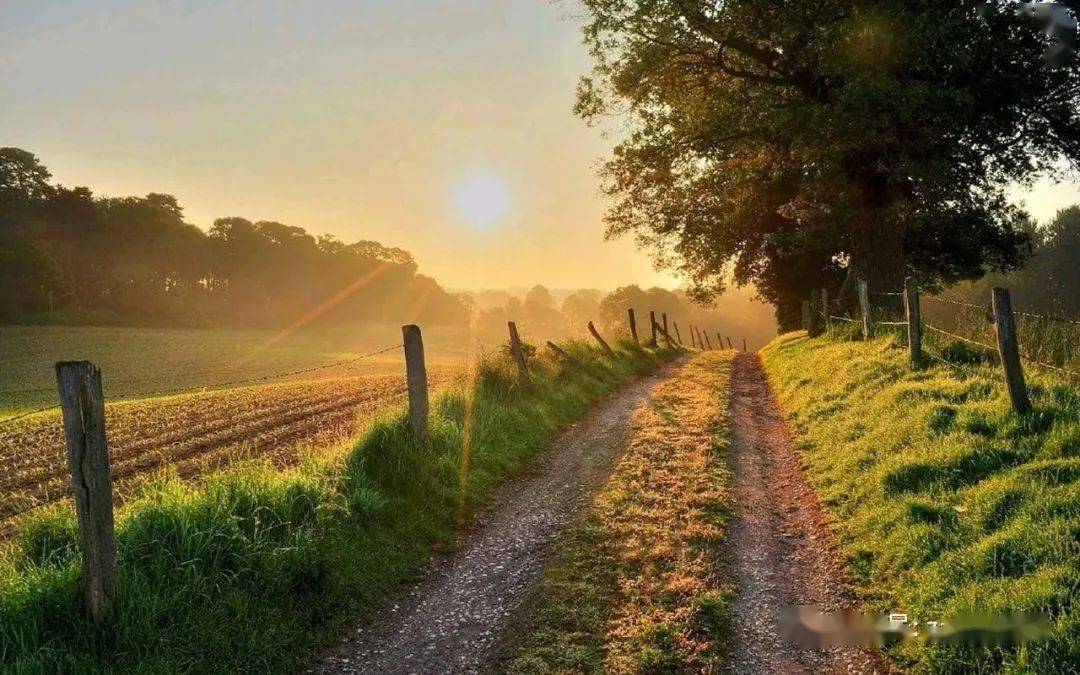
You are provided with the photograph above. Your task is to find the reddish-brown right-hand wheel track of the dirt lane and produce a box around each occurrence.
[729,354,890,673]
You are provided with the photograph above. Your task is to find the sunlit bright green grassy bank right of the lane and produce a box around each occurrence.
[764,334,1080,673]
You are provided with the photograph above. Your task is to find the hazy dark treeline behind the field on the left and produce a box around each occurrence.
[0,148,470,326]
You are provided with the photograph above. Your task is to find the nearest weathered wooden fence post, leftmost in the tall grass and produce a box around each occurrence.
[56,361,117,625]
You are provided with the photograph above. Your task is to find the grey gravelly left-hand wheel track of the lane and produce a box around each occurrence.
[314,365,675,673]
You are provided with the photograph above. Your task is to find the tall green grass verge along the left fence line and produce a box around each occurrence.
[0,345,673,673]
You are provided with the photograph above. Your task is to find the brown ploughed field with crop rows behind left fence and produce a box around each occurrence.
[0,367,455,521]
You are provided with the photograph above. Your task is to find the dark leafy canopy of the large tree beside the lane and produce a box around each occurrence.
[577,0,1080,320]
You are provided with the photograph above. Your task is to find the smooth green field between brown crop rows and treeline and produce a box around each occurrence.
[0,324,479,418]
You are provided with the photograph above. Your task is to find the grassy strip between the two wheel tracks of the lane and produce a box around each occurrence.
[510,352,733,673]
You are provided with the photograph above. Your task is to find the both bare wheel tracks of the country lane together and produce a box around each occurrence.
[312,354,888,673]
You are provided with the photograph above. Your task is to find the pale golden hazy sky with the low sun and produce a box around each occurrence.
[0,0,1080,288]
